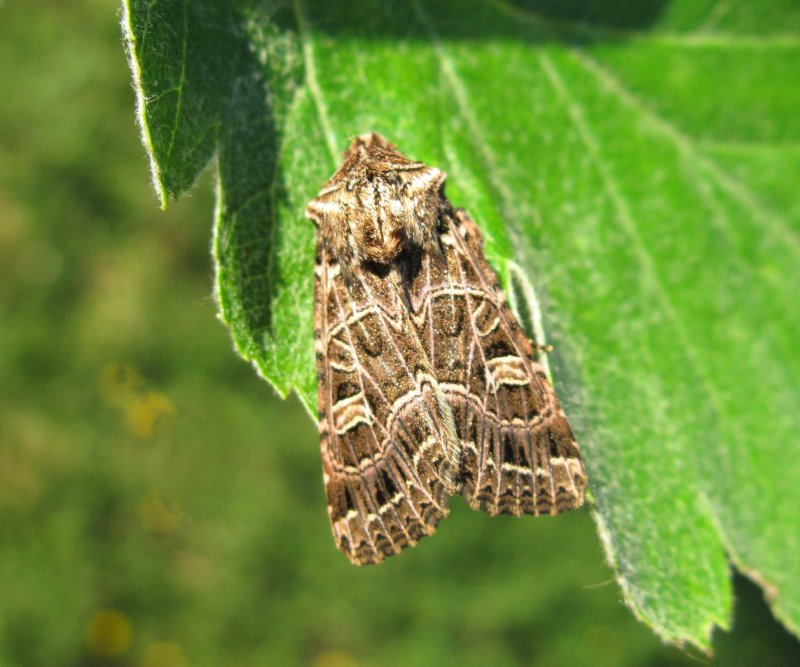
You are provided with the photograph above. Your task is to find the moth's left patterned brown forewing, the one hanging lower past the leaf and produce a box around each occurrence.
[315,243,457,564]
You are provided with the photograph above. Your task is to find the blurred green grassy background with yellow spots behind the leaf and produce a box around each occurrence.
[0,0,800,667]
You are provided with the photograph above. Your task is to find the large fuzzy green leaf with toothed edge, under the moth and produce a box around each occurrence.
[124,0,800,648]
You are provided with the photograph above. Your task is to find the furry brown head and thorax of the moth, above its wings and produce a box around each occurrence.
[306,133,446,267]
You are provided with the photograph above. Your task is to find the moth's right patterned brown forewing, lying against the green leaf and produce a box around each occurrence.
[409,206,586,516]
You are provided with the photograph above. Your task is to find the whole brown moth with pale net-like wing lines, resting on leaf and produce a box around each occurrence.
[306,133,586,565]
